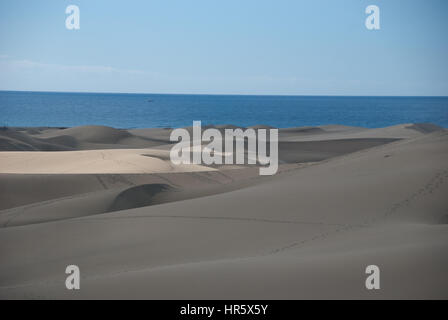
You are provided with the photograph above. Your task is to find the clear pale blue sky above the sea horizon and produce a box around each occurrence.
[0,0,448,96]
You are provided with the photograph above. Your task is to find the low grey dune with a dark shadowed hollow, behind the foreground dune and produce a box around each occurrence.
[0,170,270,228]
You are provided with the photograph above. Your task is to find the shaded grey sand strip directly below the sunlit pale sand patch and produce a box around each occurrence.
[0,166,266,212]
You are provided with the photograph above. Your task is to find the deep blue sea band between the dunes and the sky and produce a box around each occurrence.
[0,91,448,128]
